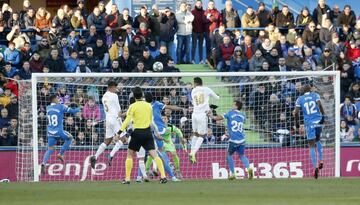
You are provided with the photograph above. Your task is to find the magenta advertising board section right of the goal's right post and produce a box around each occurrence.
[341,147,360,177]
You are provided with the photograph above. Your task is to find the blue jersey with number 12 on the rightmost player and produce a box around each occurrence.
[296,92,322,126]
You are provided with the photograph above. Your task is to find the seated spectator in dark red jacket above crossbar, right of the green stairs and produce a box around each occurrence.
[216,36,235,72]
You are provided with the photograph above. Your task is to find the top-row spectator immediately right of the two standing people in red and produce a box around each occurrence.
[221,0,241,28]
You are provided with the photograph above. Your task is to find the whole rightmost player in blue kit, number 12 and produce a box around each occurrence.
[294,85,325,179]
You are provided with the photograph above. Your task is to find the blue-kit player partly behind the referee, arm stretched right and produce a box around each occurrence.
[145,92,183,181]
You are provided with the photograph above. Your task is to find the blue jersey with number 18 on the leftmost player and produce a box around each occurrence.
[46,104,80,135]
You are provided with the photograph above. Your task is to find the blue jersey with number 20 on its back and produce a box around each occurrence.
[223,110,246,144]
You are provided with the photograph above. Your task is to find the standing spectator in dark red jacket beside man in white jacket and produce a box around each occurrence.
[191,0,207,64]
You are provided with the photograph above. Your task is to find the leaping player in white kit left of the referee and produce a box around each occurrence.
[90,81,123,169]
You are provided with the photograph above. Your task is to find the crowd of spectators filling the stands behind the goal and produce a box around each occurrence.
[0,0,360,146]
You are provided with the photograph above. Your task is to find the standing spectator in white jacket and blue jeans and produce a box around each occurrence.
[176,2,194,64]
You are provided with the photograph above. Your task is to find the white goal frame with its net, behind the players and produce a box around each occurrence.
[16,71,340,182]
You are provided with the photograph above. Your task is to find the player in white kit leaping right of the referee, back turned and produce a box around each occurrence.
[189,77,220,164]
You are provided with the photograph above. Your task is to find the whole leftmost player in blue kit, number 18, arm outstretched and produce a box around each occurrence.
[41,95,80,174]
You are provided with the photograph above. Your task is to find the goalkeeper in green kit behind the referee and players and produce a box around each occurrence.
[146,115,187,179]
